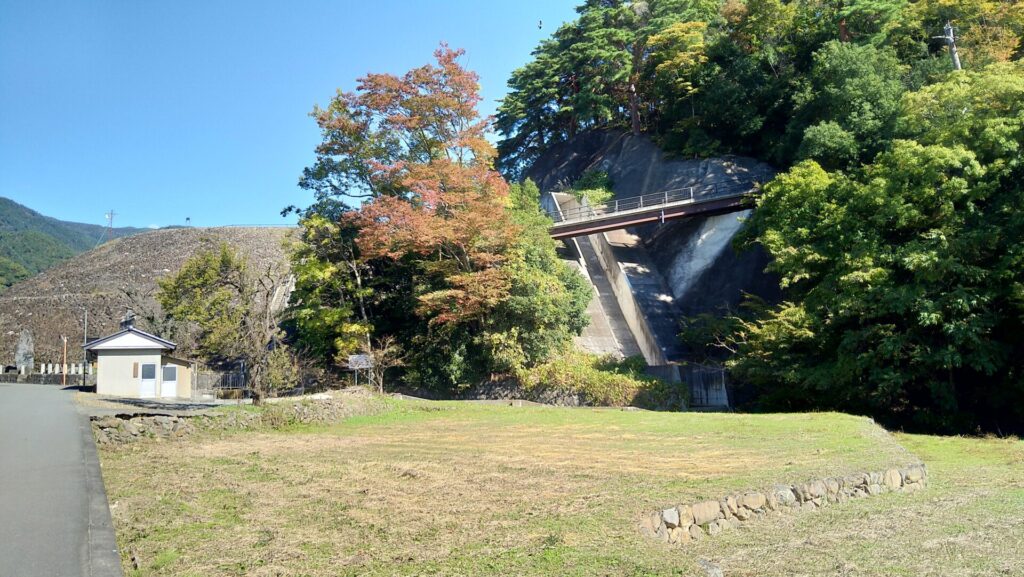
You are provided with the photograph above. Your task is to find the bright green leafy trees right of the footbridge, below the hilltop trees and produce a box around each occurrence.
[732,63,1024,430]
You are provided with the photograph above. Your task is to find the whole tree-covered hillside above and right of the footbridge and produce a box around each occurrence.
[497,0,1024,431]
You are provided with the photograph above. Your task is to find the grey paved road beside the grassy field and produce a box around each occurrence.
[0,383,121,577]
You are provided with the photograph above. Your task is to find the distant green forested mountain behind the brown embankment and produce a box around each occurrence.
[0,197,143,291]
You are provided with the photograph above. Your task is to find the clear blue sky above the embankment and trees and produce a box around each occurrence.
[0,0,577,226]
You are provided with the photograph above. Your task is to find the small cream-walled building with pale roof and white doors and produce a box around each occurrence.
[85,327,193,399]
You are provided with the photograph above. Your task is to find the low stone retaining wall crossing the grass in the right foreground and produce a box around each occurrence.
[640,464,928,543]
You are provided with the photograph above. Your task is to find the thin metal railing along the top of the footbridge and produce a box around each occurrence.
[548,173,769,224]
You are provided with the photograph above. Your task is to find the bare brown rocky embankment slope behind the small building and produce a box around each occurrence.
[0,228,292,364]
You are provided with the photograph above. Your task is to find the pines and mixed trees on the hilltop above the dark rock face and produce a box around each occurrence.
[497,0,1024,176]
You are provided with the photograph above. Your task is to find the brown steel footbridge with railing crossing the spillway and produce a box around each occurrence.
[547,173,770,240]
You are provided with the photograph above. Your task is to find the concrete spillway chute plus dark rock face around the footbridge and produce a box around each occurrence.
[525,131,780,401]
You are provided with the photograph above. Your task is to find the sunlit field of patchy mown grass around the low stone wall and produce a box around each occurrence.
[100,402,1024,576]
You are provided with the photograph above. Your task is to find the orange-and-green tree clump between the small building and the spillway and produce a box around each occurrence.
[293,45,589,388]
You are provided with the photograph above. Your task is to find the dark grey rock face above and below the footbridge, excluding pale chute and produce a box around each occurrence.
[526,131,780,361]
